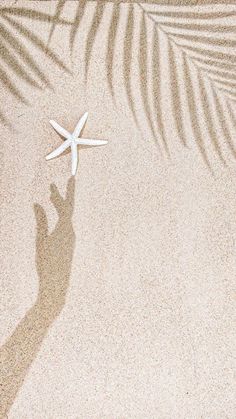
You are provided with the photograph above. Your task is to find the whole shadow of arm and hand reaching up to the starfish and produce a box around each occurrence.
[0,177,75,418]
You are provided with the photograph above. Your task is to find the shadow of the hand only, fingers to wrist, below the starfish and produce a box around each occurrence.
[34,177,75,321]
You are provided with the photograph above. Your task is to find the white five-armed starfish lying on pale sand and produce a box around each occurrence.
[46,112,108,176]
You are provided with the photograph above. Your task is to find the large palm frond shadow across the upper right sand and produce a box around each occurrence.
[70,0,236,171]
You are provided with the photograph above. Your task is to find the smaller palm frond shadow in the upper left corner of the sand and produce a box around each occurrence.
[0,7,71,125]
